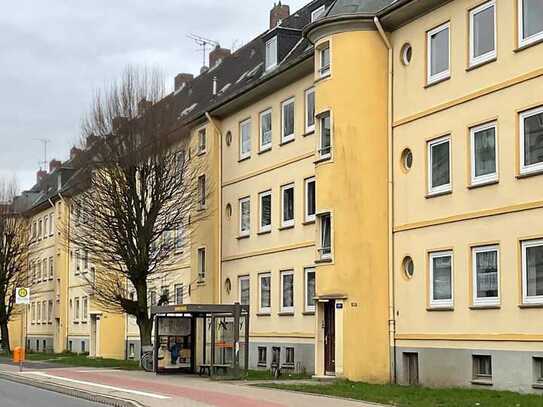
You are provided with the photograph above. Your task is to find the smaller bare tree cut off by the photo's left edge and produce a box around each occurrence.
[0,179,31,351]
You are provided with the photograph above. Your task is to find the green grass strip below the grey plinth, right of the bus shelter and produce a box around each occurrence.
[257,381,543,407]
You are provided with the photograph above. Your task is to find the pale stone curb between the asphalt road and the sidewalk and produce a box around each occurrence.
[0,371,145,407]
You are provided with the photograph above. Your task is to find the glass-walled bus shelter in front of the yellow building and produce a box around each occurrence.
[151,303,249,379]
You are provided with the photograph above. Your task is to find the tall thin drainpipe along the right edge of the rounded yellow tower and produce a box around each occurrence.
[373,17,396,383]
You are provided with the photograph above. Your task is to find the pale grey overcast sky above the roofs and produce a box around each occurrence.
[0,0,309,189]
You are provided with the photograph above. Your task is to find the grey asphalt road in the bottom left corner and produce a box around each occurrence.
[0,379,103,407]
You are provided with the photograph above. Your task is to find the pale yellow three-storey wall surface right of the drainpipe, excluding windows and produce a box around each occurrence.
[392,0,543,349]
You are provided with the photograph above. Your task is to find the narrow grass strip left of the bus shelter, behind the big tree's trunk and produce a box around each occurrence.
[26,353,140,370]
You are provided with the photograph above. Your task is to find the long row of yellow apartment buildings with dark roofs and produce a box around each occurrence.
[8,0,543,391]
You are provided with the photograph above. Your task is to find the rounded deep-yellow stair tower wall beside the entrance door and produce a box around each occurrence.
[316,31,389,382]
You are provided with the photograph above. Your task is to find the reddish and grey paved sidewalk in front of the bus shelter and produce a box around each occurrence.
[0,364,382,407]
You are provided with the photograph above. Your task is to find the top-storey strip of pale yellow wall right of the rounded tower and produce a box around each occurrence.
[391,0,543,121]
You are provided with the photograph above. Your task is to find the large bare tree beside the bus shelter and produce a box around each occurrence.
[64,68,209,346]
